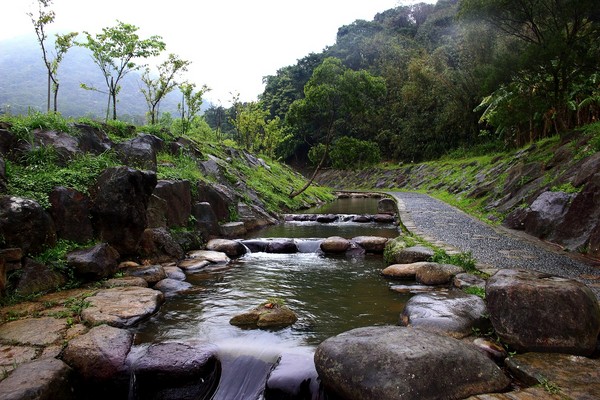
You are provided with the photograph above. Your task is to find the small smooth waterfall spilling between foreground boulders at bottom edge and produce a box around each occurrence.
[211,341,280,400]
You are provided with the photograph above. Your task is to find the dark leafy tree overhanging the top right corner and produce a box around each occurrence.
[461,0,600,132]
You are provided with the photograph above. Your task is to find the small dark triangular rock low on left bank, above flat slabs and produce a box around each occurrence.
[15,258,67,296]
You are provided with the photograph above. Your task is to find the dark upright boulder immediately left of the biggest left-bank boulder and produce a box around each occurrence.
[48,186,94,243]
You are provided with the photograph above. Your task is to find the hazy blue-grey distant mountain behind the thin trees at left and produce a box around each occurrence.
[0,36,191,124]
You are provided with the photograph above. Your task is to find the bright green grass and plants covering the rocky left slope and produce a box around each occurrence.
[0,113,334,212]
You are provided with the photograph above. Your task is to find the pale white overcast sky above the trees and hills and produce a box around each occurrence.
[0,0,433,104]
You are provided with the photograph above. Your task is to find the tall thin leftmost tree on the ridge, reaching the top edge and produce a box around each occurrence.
[27,0,78,112]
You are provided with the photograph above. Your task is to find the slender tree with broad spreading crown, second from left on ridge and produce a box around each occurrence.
[80,21,165,119]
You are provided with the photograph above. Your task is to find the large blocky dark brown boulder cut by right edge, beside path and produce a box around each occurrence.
[486,269,600,355]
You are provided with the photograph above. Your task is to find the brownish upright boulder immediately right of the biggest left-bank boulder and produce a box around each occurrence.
[153,180,192,228]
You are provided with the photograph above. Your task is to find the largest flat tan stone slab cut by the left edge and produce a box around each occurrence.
[0,317,67,346]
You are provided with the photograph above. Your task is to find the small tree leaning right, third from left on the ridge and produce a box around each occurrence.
[141,53,191,125]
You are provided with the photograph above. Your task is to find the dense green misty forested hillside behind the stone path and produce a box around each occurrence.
[207,0,600,168]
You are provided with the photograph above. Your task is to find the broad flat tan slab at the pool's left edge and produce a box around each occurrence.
[81,286,164,328]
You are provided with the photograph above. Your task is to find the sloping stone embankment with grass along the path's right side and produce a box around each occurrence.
[316,136,600,258]
